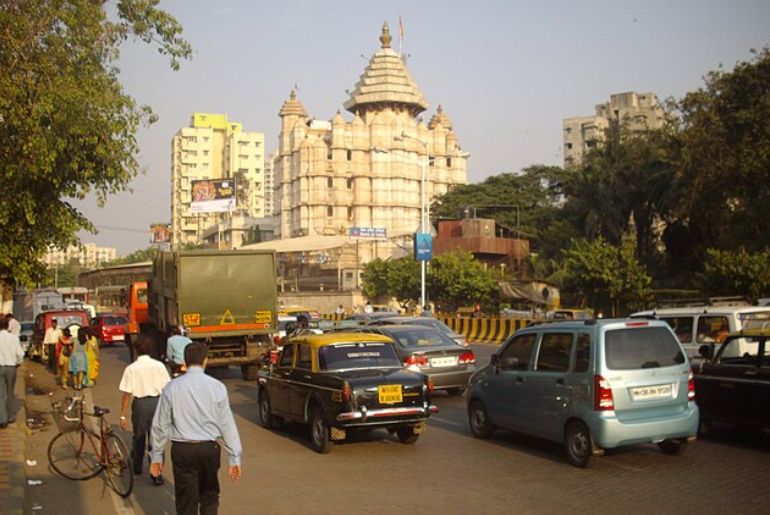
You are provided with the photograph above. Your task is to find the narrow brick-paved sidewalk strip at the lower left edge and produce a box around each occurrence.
[0,362,27,514]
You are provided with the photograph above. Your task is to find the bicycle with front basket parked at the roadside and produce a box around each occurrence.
[48,396,134,497]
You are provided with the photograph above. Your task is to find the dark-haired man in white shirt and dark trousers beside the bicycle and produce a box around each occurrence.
[118,334,170,486]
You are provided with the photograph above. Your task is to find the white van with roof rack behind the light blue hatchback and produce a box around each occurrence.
[631,306,770,358]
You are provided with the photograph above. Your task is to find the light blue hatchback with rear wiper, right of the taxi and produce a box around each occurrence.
[467,319,698,467]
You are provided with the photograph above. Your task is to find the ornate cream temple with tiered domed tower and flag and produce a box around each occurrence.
[274,24,469,262]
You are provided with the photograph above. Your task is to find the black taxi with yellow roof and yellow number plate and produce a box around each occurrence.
[257,332,438,453]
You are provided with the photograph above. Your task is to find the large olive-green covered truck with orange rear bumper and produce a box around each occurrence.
[127,250,277,380]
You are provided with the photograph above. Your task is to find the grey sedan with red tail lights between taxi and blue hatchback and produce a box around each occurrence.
[362,325,476,395]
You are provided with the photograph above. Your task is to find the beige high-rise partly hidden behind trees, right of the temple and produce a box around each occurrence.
[564,92,665,168]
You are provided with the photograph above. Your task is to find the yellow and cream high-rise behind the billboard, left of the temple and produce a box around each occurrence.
[171,113,266,248]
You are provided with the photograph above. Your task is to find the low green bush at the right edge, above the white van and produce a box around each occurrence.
[700,247,770,300]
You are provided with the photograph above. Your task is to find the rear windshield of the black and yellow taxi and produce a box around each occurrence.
[318,342,402,371]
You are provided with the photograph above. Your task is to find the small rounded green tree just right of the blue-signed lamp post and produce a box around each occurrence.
[428,251,498,311]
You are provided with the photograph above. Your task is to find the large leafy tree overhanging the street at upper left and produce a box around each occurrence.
[0,0,192,284]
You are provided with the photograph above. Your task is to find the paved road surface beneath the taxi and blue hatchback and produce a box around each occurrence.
[21,345,770,515]
